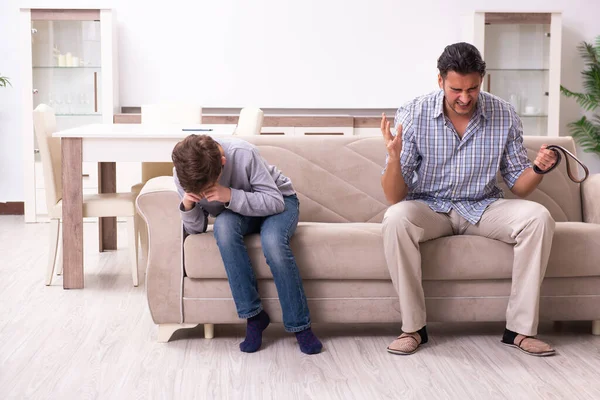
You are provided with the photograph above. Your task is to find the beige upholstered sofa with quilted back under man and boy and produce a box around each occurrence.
[137,136,600,341]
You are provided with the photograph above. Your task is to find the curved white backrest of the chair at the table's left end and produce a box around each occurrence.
[33,104,62,213]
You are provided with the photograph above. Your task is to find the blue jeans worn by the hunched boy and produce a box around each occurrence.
[214,195,310,332]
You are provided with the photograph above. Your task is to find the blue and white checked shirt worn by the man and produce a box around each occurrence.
[384,90,531,224]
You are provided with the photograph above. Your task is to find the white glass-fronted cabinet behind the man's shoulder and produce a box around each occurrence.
[471,11,562,136]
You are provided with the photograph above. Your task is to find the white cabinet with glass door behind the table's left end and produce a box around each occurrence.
[31,10,105,216]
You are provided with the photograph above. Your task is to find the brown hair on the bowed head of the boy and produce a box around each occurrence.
[171,135,223,194]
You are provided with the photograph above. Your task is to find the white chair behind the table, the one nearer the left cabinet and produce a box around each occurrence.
[142,103,202,182]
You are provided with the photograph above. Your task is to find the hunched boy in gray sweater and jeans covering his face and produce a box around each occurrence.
[172,135,323,354]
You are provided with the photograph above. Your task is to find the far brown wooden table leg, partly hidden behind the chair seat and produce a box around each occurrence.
[98,162,117,252]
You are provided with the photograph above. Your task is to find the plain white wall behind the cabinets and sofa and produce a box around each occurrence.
[0,0,600,201]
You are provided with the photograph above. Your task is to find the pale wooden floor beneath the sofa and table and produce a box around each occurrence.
[0,216,600,400]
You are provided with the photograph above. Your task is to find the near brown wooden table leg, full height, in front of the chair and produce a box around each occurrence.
[61,138,83,289]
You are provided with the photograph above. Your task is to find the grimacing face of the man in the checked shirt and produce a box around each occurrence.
[438,71,483,116]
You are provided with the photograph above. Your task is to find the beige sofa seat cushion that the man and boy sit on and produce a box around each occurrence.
[184,222,600,280]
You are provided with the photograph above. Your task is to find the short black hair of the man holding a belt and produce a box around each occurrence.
[438,42,485,79]
